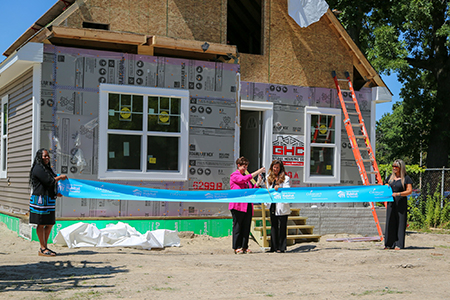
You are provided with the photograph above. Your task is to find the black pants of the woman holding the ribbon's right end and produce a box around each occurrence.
[384,197,408,249]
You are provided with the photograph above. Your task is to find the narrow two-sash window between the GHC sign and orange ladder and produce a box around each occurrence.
[303,107,341,184]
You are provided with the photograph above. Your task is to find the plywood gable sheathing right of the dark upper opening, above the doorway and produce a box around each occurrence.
[241,0,353,88]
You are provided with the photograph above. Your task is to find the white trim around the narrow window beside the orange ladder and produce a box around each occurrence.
[303,106,341,184]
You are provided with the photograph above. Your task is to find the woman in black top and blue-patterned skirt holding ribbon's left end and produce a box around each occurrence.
[30,148,67,256]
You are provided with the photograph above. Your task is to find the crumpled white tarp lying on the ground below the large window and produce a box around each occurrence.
[53,222,180,250]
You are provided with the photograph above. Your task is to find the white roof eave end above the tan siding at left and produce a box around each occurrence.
[0,43,44,88]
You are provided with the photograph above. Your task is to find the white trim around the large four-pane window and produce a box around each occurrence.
[98,83,189,181]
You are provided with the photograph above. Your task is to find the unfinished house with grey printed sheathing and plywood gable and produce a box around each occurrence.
[0,0,391,234]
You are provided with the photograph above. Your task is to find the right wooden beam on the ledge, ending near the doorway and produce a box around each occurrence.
[148,36,237,56]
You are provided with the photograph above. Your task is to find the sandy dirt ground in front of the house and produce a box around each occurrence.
[0,223,450,300]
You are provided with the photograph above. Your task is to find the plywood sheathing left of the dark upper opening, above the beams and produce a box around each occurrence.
[60,0,226,43]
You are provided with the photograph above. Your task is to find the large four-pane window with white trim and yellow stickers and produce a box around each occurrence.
[99,84,189,180]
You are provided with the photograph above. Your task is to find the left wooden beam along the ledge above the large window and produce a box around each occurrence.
[50,26,147,45]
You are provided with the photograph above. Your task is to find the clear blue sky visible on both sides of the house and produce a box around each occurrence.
[0,0,401,120]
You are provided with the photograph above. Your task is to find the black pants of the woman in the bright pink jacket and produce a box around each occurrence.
[231,203,252,250]
